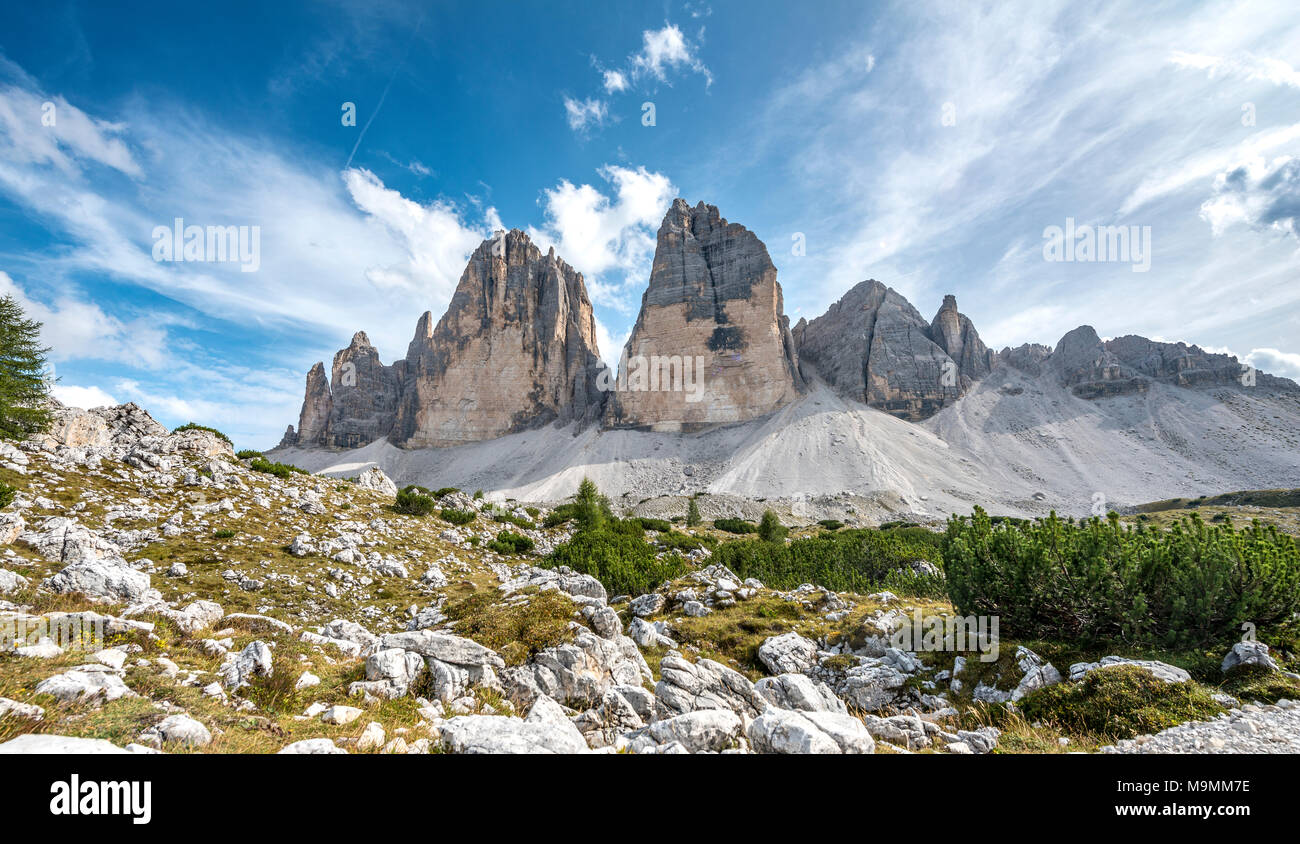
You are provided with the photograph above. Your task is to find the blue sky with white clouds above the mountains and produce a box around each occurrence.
[0,0,1300,446]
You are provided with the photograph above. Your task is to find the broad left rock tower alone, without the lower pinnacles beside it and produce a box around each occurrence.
[394,223,603,447]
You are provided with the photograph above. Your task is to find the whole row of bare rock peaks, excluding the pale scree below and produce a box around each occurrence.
[281,198,1295,449]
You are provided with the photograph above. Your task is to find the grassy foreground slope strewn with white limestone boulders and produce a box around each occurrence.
[0,404,1294,754]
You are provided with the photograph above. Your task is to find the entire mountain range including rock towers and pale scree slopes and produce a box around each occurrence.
[274,199,1300,519]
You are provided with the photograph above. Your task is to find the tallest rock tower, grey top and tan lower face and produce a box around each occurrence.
[605,199,802,430]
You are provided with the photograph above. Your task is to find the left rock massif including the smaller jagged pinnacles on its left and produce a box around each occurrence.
[282,223,605,449]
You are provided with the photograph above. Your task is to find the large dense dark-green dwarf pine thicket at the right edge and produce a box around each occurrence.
[944,507,1300,648]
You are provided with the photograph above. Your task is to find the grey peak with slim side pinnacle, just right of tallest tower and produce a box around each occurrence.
[796,281,992,421]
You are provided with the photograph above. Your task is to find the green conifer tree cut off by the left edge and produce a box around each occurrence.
[0,295,51,440]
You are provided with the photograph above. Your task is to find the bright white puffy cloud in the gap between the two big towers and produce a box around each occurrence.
[528,165,676,312]
